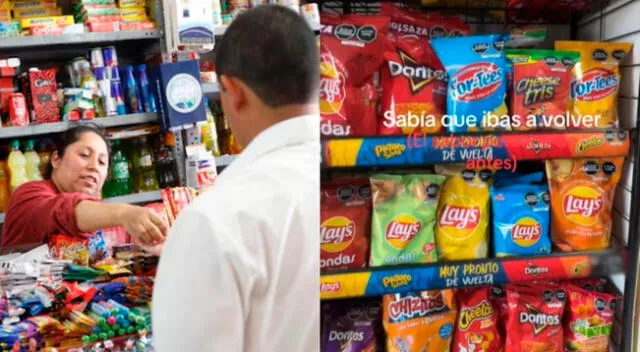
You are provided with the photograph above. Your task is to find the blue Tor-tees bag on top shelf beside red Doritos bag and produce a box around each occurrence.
[431,35,511,133]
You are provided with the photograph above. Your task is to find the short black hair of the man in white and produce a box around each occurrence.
[215,5,320,108]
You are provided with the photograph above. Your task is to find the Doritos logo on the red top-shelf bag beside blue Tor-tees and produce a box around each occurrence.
[389,50,447,94]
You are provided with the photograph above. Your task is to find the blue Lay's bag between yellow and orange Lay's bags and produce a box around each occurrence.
[490,173,551,257]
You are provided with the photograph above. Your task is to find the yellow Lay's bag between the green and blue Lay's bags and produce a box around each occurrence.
[436,165,491,260]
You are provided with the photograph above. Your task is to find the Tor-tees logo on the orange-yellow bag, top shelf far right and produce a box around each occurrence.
[571,67,619,101]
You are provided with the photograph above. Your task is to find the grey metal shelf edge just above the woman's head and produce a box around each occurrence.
[0,113,158,139]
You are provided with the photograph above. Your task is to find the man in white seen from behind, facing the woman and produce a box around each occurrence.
[153,5,320,352]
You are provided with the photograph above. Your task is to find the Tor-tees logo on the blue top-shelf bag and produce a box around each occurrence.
[451,62,503,102]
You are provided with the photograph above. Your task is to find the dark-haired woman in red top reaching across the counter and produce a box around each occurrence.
[2,124,168,249]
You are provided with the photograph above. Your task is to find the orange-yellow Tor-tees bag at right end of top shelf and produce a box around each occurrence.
[555,41,631,128]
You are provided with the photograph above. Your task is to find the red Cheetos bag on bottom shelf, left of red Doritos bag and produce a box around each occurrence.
[451,286,503,352]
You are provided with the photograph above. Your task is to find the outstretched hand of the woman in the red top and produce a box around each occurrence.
[121,205,169,245]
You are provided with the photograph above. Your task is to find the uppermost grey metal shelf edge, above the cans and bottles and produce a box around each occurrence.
[0,29,162,50]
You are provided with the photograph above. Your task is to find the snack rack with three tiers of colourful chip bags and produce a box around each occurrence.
[319,0,640,352]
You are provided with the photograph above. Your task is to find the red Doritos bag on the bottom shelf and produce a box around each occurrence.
[505,283,567,352]
